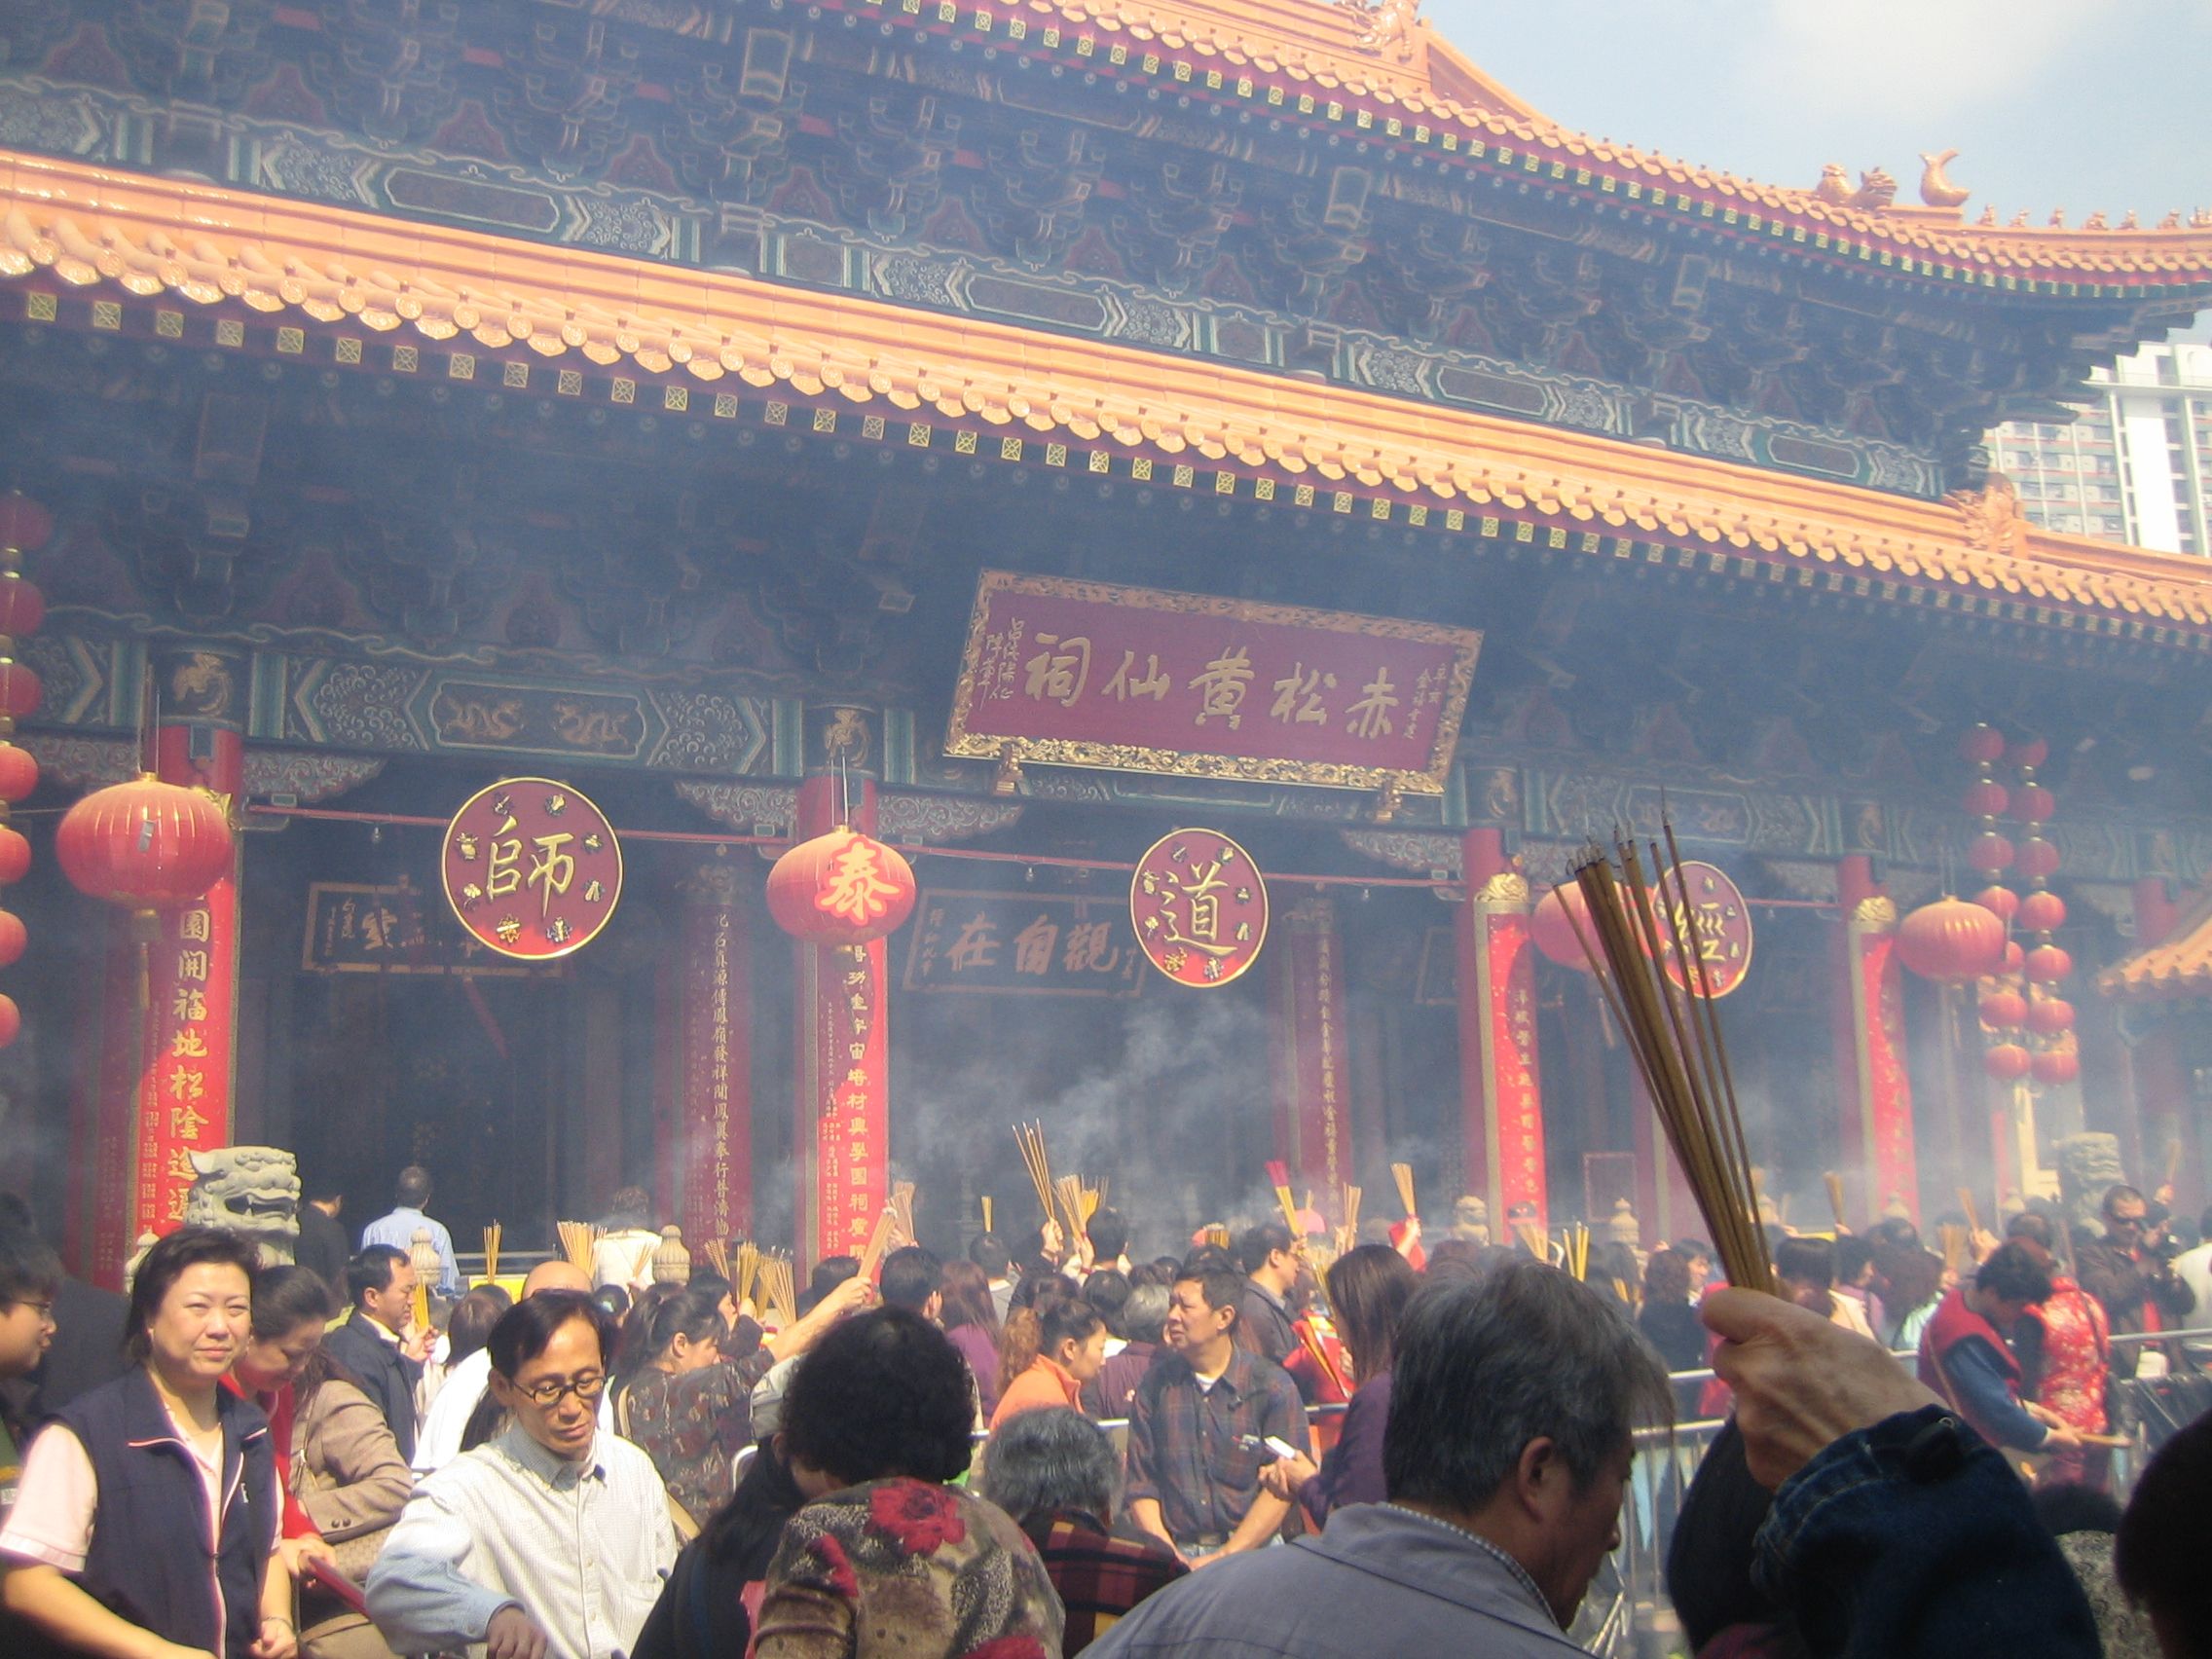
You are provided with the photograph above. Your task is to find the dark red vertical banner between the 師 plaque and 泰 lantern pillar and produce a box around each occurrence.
[677,865,752,1243]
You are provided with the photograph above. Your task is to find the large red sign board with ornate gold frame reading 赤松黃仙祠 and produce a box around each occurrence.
[944,571,1482,794]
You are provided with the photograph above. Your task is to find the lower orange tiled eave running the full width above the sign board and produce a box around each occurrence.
[13,153,2212,648]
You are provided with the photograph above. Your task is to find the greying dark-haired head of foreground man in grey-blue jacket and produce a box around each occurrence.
[1382,1261,1673,1628]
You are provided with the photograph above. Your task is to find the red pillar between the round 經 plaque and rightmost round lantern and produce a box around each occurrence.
[1833,854,1920,1226]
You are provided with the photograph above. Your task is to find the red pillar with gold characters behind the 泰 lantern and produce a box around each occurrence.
[792,774,892,1263]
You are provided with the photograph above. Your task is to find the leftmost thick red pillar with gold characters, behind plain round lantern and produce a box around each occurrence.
[78,650,245,1287]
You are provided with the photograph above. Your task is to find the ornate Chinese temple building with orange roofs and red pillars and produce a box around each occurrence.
[0,0,2212,1278]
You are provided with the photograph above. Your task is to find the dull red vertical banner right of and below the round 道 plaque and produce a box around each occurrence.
[1272,898,1356,1210]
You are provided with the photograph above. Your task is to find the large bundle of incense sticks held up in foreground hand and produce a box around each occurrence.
[1568,827,1774,1292]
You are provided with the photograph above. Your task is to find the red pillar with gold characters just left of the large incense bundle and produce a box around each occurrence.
[1457,830,1548,1243]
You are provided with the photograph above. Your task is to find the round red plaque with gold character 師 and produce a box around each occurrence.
[440,779,621,962]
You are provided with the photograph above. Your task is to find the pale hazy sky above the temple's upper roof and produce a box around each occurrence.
[1422,0,2212,223]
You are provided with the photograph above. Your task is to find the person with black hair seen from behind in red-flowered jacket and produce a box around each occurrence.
[752,1308,1064,1659]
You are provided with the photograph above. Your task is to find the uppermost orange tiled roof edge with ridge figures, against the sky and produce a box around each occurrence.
[893,0,2212,285]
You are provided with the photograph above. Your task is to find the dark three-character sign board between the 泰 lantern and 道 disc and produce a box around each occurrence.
[903,887,1141,998]
